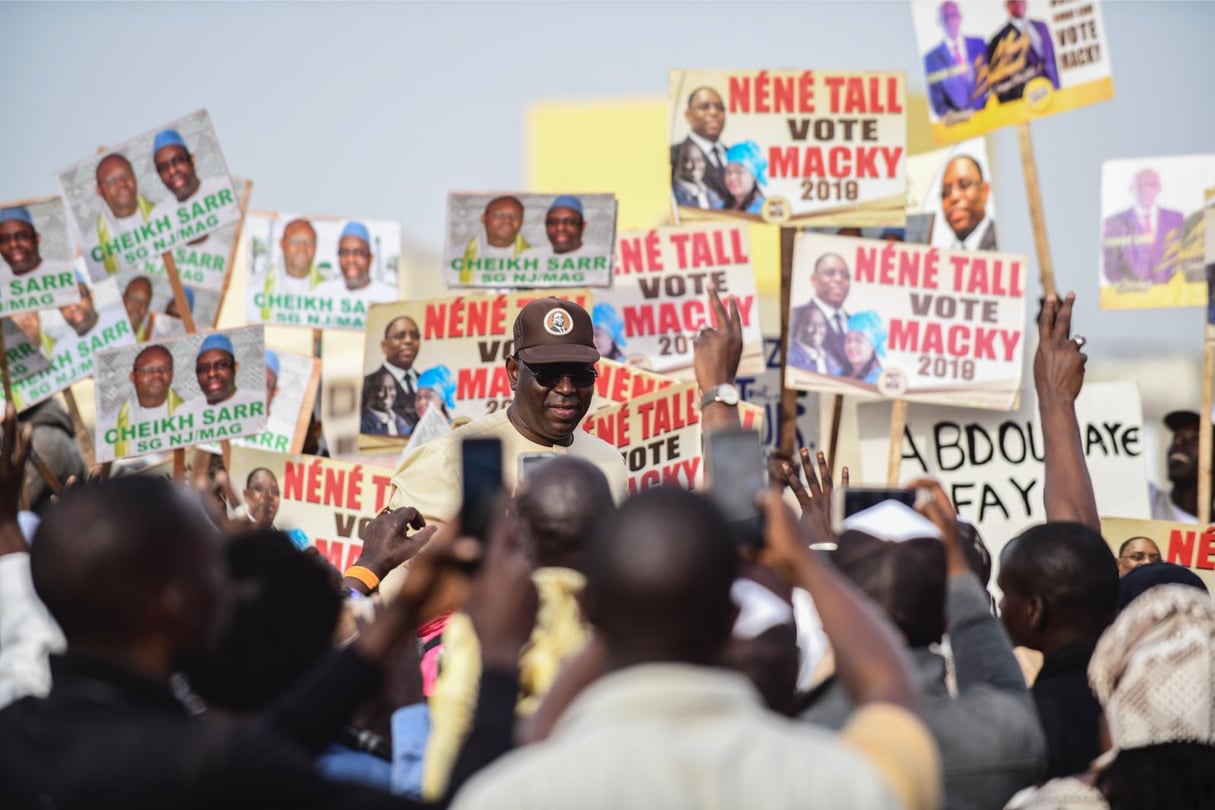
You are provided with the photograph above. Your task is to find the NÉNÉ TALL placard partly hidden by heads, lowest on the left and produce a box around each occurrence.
[228,446,392,571]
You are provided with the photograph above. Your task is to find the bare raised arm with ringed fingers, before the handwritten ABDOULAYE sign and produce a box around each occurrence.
[1034,293,1101,532]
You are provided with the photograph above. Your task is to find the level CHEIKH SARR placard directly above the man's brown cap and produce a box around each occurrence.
[443,192,616,289]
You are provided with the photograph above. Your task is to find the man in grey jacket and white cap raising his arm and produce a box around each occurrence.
[802,481,1046,809]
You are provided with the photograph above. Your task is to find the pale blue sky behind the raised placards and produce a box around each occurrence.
[0,0,1215,356]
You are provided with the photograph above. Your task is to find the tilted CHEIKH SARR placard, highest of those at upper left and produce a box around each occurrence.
[58,109,241,279]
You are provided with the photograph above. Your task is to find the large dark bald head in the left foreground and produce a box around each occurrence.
[29,476,225,664]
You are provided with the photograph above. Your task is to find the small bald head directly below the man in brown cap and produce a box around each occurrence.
[515,455,616,570]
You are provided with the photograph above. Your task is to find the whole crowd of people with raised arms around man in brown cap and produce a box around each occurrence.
[0,291,1215,809]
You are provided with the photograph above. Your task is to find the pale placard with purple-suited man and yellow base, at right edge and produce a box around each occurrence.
[1100,154,1215,310]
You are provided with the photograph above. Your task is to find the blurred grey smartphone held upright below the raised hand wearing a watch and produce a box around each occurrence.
[705,430,765,548]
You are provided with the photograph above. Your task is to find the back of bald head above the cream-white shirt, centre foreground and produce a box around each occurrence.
[583,487,740,668]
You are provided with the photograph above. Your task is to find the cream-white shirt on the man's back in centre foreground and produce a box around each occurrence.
[453,664,932,810]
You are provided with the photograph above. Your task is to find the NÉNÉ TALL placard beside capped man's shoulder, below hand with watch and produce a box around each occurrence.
[582,383,763,494]
